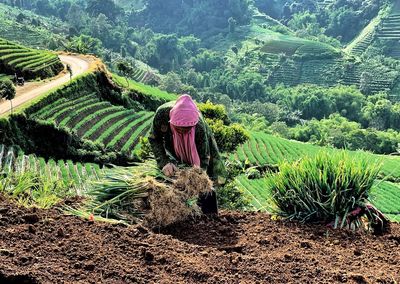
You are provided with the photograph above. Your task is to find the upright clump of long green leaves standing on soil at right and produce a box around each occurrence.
[268,151,389,233]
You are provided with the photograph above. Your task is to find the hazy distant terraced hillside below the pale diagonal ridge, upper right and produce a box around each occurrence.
[228,22,399,93]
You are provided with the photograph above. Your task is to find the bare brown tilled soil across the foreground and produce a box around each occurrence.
[0,196,400,284]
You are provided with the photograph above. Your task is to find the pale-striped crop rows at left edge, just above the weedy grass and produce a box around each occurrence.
[0,144,103,195]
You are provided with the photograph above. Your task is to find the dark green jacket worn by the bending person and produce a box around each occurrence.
[149,101,226,181]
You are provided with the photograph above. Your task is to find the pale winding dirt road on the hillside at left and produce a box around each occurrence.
[0,55,90,115]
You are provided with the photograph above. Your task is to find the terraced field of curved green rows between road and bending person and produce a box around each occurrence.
[32,93,153,155]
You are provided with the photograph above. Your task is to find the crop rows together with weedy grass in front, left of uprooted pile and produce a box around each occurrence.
[0,144,102,200]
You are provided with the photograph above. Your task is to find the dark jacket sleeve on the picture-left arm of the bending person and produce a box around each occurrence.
[149,109,170,169]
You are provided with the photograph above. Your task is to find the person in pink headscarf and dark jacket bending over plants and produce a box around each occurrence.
[149,95,225,214]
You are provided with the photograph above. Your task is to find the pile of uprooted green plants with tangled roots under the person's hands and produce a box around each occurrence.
[73,162,213,228]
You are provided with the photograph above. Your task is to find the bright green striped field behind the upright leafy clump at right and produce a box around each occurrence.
[229,133,400,220]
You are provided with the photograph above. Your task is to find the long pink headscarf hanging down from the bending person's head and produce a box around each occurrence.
[169,95,200,167]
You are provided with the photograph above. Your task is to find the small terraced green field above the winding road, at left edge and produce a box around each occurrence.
[0,38,64,79]
